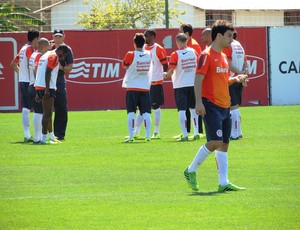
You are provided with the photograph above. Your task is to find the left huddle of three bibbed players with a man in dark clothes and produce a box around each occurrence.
[11,29,73,144]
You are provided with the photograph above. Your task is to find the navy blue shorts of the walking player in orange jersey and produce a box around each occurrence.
[202,98,231,144]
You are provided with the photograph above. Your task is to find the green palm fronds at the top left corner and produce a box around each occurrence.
[0,1,45,32]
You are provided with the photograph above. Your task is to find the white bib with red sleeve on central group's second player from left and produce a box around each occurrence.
[145,43,168,83]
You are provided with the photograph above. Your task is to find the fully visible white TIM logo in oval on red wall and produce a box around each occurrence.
[67,57,125,84]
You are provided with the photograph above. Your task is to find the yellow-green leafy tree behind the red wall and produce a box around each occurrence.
[77,0,185,29]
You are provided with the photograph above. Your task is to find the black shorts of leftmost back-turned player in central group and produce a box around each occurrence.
[126,90,151,115]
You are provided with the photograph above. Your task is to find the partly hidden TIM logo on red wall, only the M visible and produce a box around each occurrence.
[246,55,266,79]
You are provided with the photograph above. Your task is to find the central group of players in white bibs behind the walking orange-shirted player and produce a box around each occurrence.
[123,24,247,142]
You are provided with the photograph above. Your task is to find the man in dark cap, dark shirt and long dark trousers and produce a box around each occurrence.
[53,29,74,140]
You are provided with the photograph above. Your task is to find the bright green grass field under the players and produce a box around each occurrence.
[0,106,300,229]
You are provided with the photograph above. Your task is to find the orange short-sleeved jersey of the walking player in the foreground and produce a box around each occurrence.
[197,47,230,108]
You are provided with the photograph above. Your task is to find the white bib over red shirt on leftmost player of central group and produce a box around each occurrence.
[122,51,151,91]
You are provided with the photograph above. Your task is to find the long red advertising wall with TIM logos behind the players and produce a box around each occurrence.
[0,28,268,110]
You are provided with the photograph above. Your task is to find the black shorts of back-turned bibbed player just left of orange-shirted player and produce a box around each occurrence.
[174,86,196,111]
